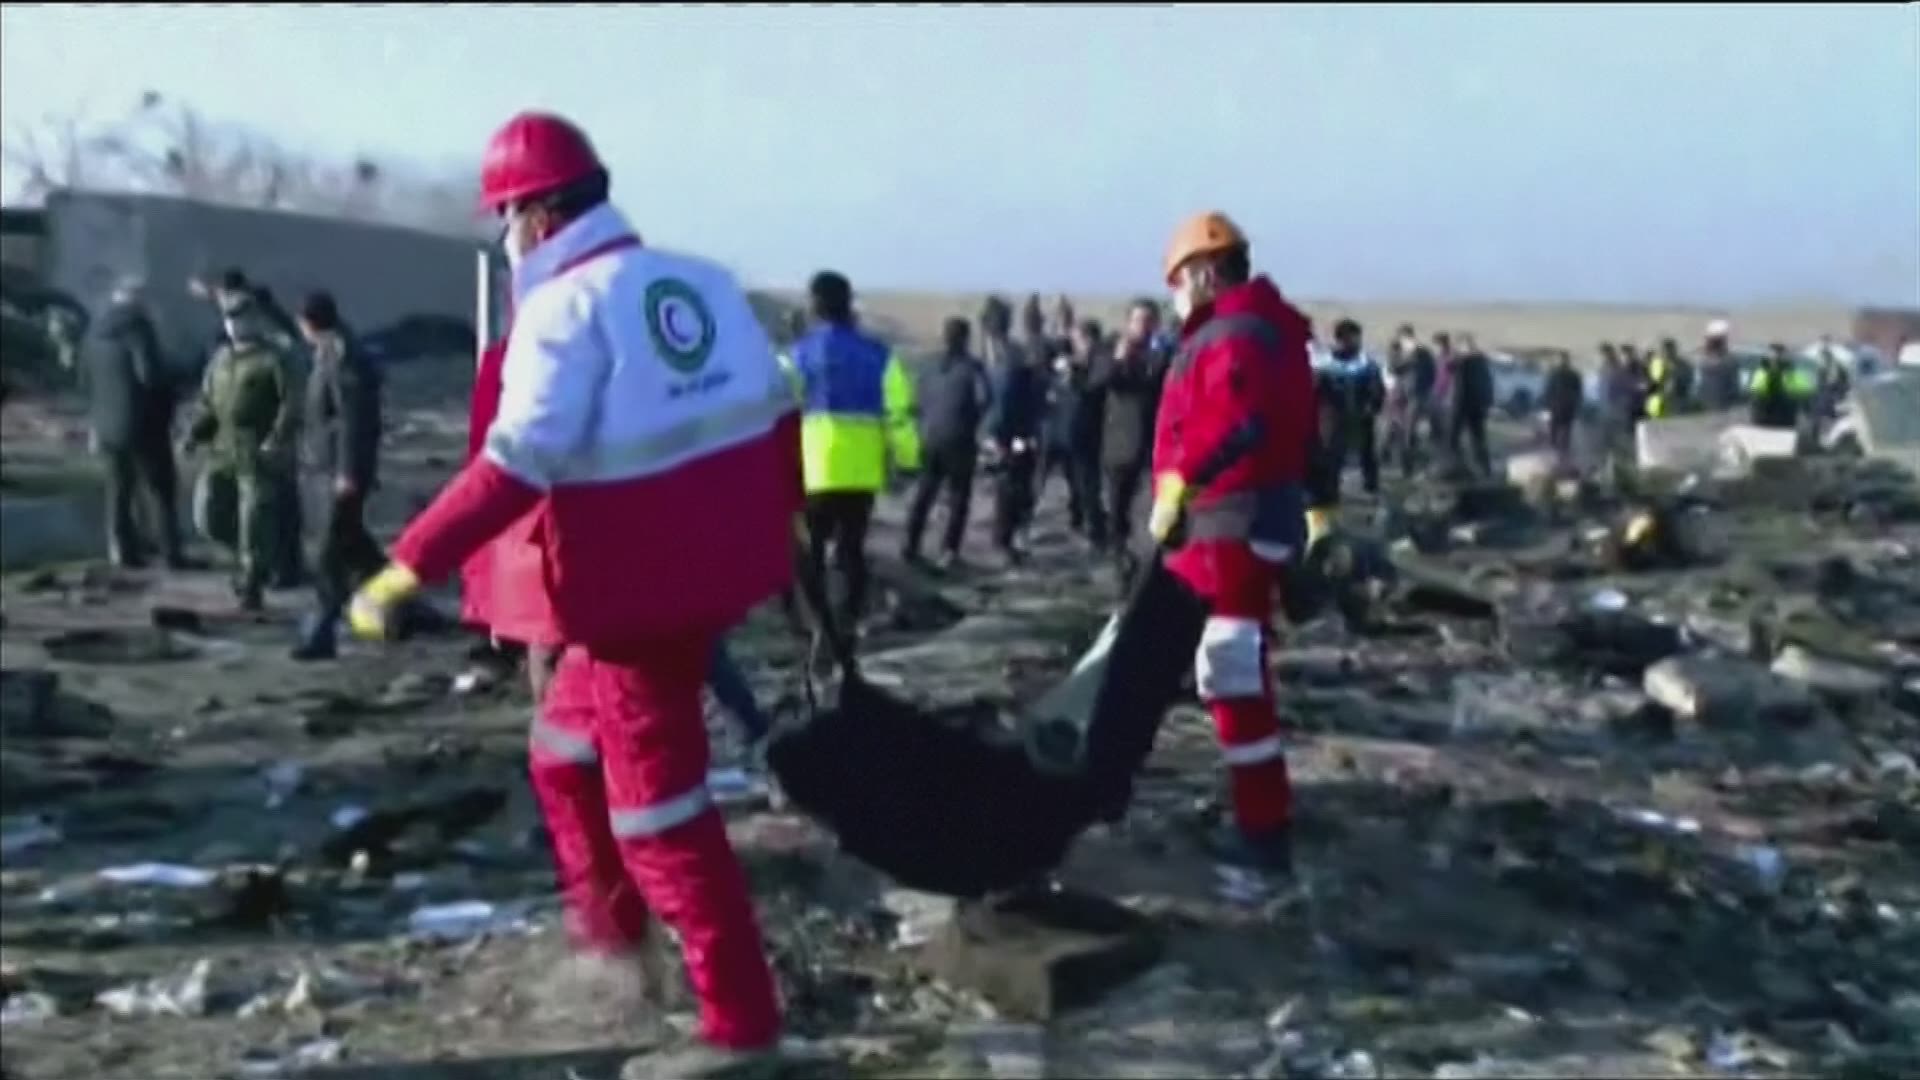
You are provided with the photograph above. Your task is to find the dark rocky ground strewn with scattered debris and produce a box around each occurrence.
[0,372,1920,1080]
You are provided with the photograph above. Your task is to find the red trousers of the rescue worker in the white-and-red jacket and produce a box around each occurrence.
[530,634,780,1049]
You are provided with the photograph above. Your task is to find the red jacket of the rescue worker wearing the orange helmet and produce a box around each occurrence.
[1154,277,1317,594]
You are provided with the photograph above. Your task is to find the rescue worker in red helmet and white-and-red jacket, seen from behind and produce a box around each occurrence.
[349,113,801,1076]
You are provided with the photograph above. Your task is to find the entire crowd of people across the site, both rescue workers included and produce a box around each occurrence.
[52,102,1881,1076]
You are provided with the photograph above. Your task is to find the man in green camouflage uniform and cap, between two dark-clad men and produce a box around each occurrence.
[186,294,300,611]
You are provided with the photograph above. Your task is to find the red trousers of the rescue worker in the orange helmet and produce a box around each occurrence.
[1167,540,1294,834]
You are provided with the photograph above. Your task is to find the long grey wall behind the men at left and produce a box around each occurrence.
[42,192,476,359]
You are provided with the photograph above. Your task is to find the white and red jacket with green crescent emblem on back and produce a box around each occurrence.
[394,206,803,648]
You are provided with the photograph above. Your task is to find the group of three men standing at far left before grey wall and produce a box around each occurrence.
[81,269,384,659]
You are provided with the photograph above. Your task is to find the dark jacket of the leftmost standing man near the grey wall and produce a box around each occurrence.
[83,304,173,454]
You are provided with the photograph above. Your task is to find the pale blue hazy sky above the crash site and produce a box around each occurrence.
[0,4,1920,304]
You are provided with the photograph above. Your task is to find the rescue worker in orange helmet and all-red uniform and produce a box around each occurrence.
[1150,213,1317,872]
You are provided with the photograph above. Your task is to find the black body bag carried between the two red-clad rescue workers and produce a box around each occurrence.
[766,429,1258,897]
